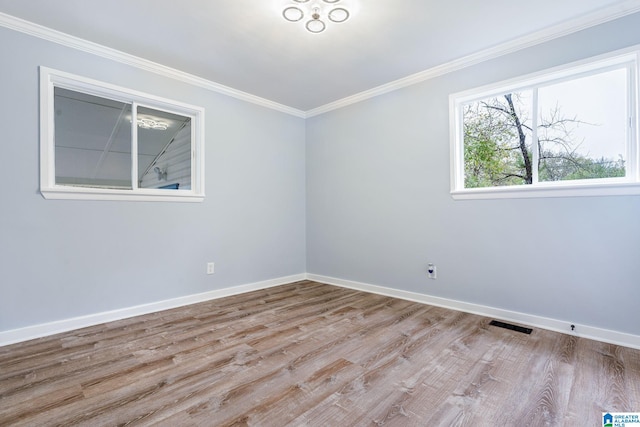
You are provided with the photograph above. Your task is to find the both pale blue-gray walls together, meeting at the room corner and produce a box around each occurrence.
[0,11,640,334]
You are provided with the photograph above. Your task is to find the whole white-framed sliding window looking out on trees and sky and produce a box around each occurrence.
[450,52,640,199]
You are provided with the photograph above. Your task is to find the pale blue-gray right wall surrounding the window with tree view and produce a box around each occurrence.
[307,14,640,340]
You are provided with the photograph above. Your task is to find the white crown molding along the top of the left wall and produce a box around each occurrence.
[0,12,306,118]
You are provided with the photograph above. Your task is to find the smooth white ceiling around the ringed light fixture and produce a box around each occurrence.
[0,0,640,112]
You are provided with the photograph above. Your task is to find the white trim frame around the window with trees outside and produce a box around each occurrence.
[449,45,640,200]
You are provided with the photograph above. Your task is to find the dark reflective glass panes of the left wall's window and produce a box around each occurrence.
[54,87,192,190]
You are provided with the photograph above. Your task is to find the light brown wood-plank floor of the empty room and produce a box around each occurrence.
[0,281,640,427]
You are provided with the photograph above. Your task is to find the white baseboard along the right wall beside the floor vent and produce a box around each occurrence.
[307,273,640,349]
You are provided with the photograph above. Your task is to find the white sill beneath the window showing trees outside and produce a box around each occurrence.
[451,182,640,200]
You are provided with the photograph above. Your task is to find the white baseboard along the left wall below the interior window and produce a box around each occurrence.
[0,274,306,346]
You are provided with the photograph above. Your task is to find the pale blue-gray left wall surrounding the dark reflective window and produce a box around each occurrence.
[0,27,306,331]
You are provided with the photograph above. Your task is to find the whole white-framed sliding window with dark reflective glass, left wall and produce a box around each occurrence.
[40,67,204,202]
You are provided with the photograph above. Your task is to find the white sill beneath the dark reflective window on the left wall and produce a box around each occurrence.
[40,187,204,203]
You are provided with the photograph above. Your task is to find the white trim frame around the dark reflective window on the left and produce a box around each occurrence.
[40,66,205,202]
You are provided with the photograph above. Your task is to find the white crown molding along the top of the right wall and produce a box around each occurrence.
[305,0,640,118]
